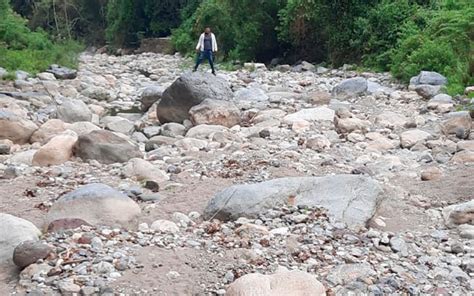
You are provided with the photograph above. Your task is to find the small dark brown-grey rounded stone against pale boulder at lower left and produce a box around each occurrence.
[13,240,51,268]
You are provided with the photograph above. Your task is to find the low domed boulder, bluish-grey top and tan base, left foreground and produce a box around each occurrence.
[45,183,141,228]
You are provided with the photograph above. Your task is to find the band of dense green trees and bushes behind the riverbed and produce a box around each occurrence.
[0,0,474,92]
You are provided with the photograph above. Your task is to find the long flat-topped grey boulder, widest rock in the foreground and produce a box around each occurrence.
[205,175,382,227]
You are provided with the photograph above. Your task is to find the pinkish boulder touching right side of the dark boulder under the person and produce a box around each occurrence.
[189,99,240,127]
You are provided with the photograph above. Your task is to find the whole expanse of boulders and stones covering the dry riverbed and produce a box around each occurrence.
[0,53,474,295]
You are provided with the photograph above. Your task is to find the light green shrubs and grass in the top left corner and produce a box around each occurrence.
[0,0,81,73]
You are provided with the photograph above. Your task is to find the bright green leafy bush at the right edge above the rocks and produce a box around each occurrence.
[391,2,474,94]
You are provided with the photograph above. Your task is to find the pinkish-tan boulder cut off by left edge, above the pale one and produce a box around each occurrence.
[0,109,38,144]
